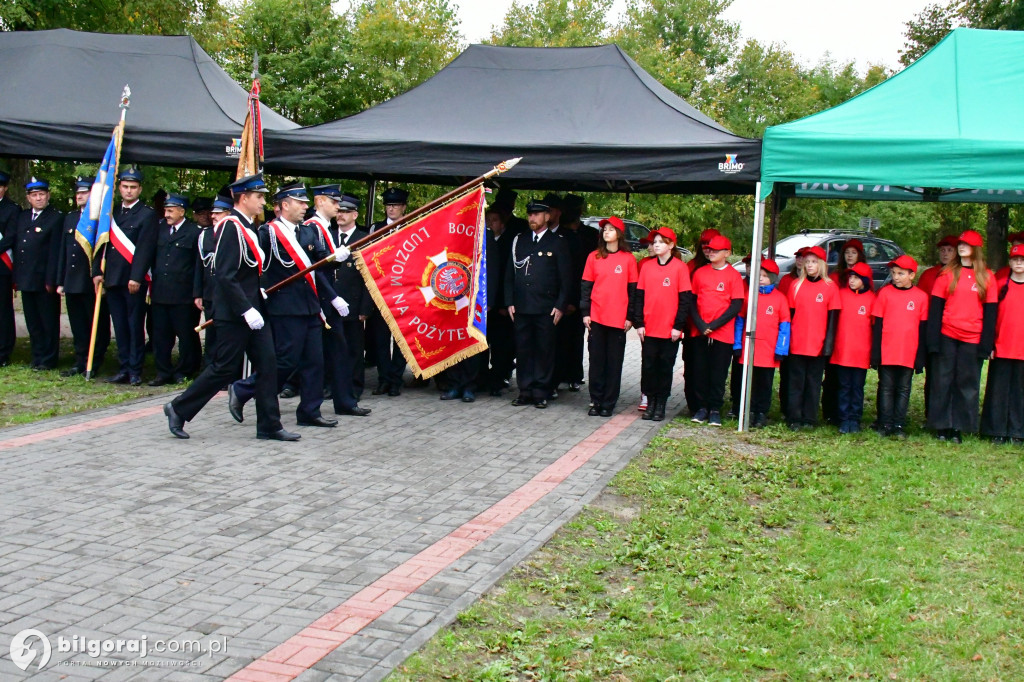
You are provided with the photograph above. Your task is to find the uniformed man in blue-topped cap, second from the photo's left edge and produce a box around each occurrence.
[13,178,63,370]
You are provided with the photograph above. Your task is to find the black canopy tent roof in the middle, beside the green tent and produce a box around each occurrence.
[266,45,761,194]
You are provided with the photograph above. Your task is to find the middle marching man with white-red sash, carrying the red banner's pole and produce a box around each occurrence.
[227,183,348,427]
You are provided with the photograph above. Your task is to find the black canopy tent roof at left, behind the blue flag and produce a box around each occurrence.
[0,29,298,169]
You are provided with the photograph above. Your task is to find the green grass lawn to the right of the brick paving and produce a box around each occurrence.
[389,378,1024,681]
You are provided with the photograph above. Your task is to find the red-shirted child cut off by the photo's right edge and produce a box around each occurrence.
[981,243,1024,445]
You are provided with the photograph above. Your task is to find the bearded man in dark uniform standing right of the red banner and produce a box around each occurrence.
[505,200,572,408]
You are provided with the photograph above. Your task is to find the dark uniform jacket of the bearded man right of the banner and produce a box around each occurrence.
[505,229,572,314]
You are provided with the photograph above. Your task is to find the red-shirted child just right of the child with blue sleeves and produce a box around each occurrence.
[786,247,842,431]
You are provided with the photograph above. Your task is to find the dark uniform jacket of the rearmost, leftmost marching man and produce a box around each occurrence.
[213,209,266,325]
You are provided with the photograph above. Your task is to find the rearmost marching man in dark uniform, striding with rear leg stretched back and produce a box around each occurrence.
[164,173,301,440]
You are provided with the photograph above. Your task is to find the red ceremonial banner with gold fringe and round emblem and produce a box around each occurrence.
[352,186,487,378]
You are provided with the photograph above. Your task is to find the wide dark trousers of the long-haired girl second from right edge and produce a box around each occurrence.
[928,334,982,433]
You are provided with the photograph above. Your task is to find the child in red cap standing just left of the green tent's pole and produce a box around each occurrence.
[686,235,745,426]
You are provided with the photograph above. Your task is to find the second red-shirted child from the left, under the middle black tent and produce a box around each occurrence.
[631,227,690,422]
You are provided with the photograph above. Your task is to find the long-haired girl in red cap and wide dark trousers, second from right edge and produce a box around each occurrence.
[928,229,999,443]
